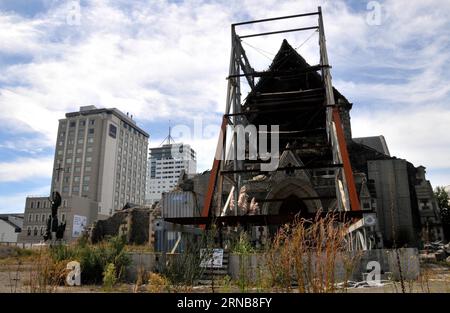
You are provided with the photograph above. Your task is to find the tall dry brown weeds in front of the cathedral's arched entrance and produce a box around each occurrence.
[265,212,356,293]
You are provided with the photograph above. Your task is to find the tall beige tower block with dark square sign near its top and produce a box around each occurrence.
[52,106,149,216]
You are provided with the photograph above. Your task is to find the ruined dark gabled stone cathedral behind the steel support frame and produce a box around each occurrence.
[160,35,444,250]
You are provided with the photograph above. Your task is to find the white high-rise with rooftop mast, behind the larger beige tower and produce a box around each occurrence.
[145,142,197,204]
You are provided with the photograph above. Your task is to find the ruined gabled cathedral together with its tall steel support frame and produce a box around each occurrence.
[112,8,445,252]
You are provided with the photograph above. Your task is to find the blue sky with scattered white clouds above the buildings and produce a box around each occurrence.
[0,0,450,213]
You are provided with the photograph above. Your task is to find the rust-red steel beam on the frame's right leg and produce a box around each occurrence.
[333,107,361,211]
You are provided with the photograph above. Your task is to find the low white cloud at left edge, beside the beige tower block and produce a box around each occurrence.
[0,157,53,183]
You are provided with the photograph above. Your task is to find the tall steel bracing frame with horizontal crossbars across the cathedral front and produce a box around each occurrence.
[197,7,361,229]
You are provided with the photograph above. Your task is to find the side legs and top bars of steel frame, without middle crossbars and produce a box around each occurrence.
[202,7,361,228]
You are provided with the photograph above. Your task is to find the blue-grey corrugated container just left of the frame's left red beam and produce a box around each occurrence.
[161,191,200,218]
